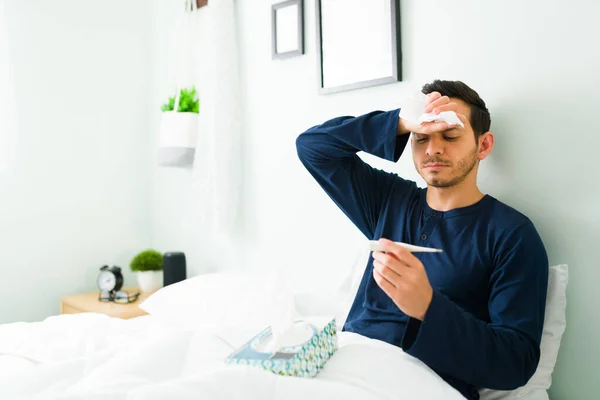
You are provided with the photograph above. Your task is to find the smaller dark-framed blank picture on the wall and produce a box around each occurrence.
[271,0,304,59]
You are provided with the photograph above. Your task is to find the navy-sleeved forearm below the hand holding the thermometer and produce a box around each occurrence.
[402,292,540,390]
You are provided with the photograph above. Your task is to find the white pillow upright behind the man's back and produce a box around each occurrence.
[480,264,569,400]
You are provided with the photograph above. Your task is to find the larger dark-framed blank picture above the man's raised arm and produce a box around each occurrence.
[316,0,402,94]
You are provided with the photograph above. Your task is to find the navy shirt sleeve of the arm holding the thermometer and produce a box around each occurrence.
[402,222,549,390]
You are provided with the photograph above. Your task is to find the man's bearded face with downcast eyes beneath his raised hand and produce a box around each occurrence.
[411,99,479,188]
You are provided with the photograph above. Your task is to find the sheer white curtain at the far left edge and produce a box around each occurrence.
[0,2,17,174]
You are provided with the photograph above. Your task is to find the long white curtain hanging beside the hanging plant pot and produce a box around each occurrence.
[184,0,242,236]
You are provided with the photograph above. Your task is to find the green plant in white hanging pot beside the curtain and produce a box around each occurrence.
[159,86,200,166]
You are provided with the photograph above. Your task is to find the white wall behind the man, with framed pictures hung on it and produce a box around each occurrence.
[153,0,600,399]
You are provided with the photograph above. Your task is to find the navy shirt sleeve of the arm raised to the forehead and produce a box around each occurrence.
[296,109,412,239]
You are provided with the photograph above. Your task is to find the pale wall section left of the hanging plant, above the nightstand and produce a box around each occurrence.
[0,0,152,322]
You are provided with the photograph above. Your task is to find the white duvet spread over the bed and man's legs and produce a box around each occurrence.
[0,313,463,400]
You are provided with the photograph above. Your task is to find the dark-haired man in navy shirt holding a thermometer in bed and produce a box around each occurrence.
[296,80,549,399]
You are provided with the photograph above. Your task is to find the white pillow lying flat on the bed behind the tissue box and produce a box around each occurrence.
[140,271,294,333]
